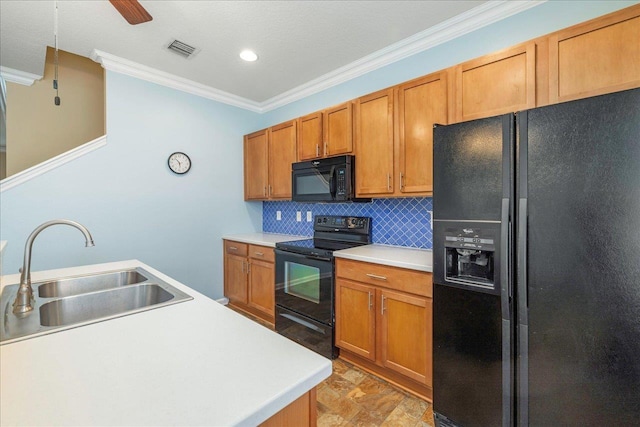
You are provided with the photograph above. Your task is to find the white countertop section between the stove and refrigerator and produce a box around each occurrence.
[333,244,433,272]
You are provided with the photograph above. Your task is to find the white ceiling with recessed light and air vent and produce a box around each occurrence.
[0,0,540,110]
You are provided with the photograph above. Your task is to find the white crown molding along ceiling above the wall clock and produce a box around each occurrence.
[90,49,261,113]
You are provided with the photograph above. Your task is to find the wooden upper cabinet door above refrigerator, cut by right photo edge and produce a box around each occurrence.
[549,6,640,103]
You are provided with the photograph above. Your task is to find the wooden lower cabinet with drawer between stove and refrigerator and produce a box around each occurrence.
[336,259,433,401]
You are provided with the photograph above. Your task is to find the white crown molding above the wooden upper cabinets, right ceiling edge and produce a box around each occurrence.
[261,0,547,112]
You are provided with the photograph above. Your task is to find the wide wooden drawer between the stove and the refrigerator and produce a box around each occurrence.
[336,259,433,298]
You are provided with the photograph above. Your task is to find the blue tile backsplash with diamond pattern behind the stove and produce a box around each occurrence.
[262,197,433,249]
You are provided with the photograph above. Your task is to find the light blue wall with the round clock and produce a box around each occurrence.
[0,72,262,298]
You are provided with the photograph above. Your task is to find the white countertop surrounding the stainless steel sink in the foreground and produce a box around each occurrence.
[0,260,331,426]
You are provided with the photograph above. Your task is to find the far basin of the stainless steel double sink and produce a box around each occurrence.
[38,270,147,298]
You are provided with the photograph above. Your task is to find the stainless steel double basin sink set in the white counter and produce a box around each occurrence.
[0,267,193,345]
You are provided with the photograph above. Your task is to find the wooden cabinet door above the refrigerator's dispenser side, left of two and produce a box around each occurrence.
[455,42,536,122]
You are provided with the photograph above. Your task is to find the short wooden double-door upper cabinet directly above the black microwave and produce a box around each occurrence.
[298,101,353,161]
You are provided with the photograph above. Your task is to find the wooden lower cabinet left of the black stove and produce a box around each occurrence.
[224,240,275,324]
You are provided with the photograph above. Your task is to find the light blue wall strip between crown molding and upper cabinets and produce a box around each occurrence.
[253,0,639,130]
